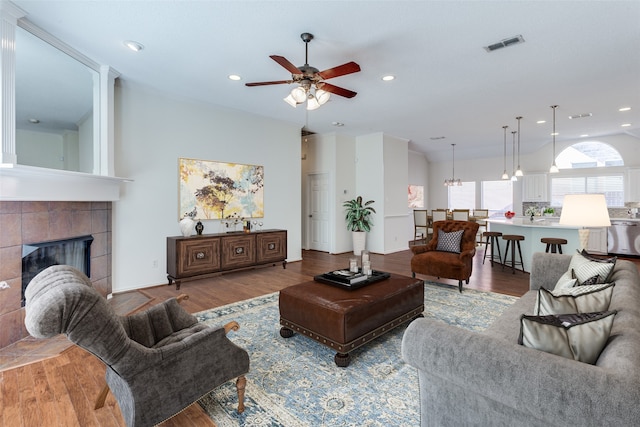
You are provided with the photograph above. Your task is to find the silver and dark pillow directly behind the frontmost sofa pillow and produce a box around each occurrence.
[533,283,615,316]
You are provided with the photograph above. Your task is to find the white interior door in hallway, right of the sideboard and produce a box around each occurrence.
[307,173,329,252]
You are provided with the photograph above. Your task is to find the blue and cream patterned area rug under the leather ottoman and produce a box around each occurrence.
[196,282,516,427]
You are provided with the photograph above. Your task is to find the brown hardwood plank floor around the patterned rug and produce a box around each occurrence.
[0,249,640,427]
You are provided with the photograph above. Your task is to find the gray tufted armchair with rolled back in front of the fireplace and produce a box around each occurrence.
[25,265,249,427]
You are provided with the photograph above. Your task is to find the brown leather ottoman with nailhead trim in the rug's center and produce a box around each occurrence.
[279,274,424,367]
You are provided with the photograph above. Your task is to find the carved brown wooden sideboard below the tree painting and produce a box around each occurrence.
[167,230,287,289]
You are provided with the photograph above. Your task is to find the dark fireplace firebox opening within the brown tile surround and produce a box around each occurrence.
[21,236,93,307]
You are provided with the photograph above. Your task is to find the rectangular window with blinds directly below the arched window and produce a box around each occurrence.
[551,174,624,208]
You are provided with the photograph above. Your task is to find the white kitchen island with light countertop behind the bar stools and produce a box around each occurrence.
[487,216,580,272]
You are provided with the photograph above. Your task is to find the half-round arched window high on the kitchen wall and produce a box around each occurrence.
[556,141,624,169]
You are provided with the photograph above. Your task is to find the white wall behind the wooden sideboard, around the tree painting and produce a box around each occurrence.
[113,83,301,292]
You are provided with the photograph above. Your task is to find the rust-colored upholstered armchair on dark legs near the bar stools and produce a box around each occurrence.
[411,220,478,292]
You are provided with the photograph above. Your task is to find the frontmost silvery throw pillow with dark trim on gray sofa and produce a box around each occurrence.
[518,311,616,364]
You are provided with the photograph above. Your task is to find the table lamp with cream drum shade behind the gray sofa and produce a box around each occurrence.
[560,194,611,251]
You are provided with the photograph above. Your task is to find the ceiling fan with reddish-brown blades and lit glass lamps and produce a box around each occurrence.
[246,33,360,110]
